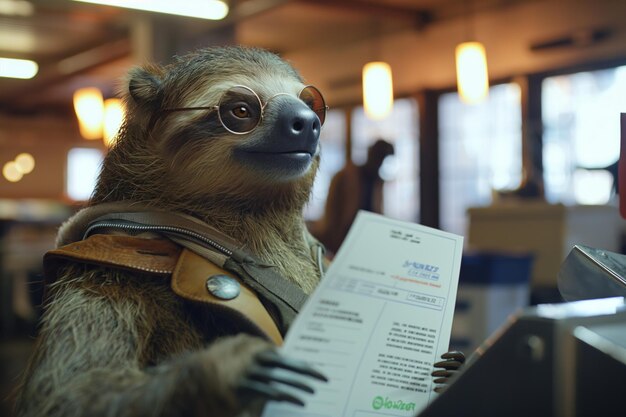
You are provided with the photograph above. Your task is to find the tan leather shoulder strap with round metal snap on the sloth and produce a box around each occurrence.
[44,234,282,345]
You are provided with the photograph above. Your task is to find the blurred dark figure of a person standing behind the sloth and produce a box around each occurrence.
[310,139,394,254]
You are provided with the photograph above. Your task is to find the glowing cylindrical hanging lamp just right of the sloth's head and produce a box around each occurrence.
[363,62,393,120]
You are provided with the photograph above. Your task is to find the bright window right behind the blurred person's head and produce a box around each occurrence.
[352,98,419,221]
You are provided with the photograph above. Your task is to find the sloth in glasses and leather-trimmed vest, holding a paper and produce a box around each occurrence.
[16,46,460,417]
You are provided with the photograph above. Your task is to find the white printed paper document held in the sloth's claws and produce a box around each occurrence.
[263,211,463,417]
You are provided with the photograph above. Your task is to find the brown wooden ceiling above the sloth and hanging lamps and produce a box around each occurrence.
[0,0,626,114]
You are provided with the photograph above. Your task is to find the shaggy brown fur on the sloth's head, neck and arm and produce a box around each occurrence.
[16,47,320,417]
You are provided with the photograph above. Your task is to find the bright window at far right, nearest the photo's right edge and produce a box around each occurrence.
[541,66,626,204]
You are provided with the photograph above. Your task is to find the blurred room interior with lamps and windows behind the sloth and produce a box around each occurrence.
[0,0,626,415]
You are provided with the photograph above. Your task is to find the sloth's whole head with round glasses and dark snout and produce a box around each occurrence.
[129,48,326,200]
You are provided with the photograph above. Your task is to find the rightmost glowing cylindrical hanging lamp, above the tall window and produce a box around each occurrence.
[456,42,489,104]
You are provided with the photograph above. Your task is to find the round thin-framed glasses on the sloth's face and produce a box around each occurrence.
[162,85,328,135]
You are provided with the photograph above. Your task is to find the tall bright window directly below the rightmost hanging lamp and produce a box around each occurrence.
[439,83,522,235]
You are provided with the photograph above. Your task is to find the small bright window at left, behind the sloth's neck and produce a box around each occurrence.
[66,148,103,201]
